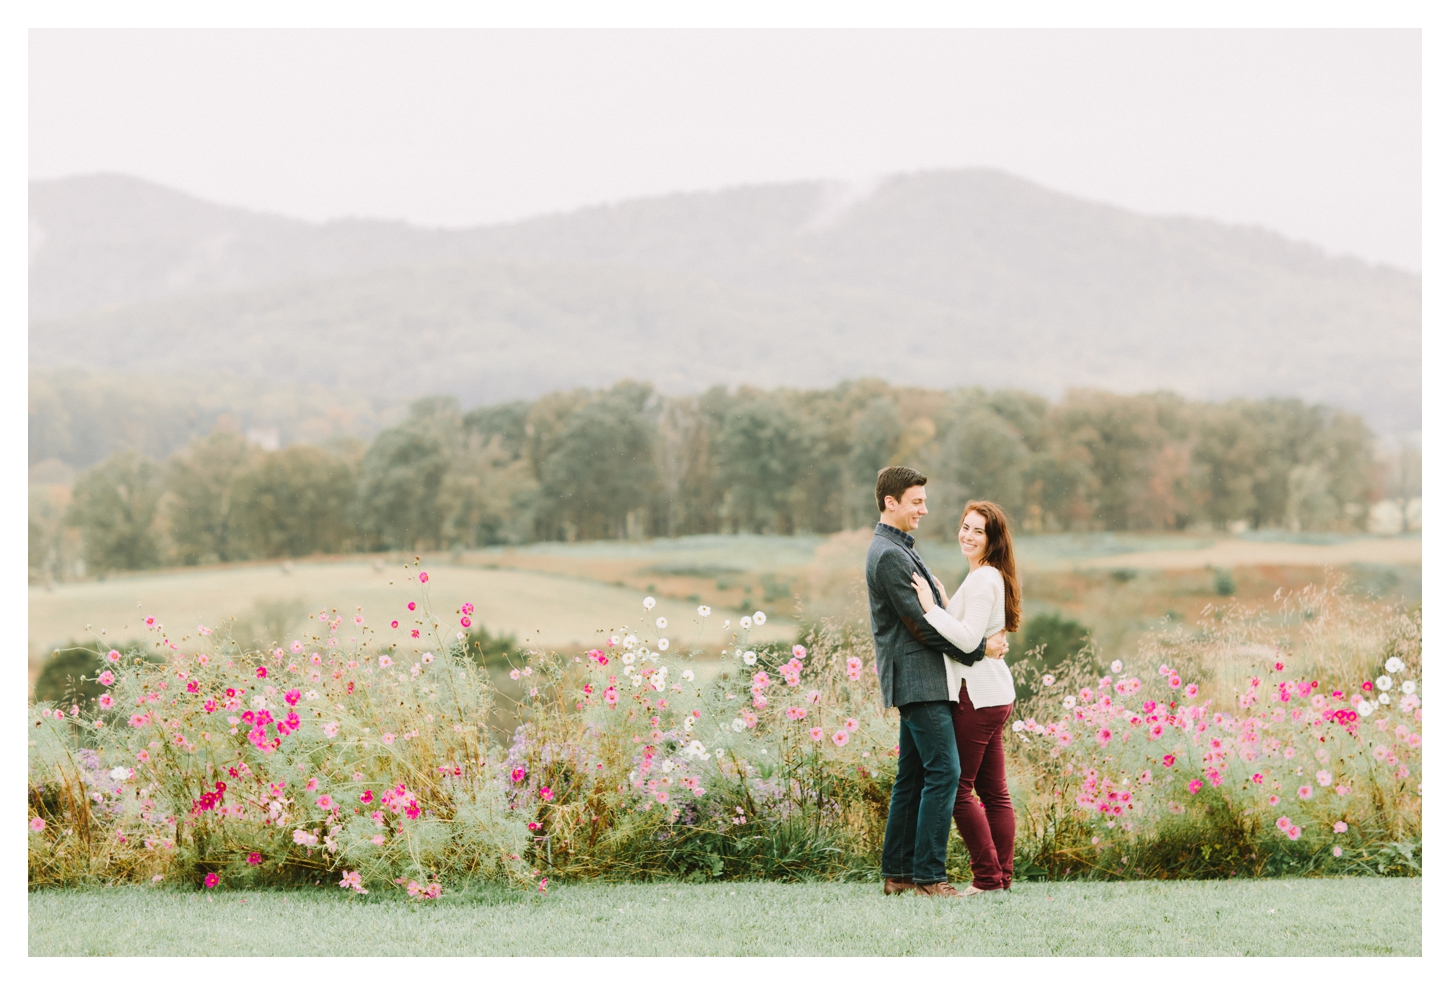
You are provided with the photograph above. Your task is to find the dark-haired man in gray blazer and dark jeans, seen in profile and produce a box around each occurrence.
[866,466,1006,897]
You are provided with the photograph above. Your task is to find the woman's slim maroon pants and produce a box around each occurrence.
[951,685,1016,889]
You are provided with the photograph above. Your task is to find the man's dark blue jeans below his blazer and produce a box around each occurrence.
[882,701,961,883]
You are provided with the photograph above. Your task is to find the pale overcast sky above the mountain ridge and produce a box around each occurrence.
[29,30,1421,270]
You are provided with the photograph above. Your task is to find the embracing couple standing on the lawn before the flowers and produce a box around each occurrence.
[866,466,1022,897]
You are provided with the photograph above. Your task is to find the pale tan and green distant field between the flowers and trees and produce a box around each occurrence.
[29,531,1421,679]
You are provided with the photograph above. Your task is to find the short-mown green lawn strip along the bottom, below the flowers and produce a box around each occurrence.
[29,879,1421,956]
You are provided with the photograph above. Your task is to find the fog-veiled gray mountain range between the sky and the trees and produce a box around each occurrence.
[30,170,1421,432]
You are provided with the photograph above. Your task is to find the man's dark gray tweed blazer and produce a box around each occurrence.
[866,524,986,708]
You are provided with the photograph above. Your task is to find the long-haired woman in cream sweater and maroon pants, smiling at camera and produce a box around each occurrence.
[912,500,1022,897]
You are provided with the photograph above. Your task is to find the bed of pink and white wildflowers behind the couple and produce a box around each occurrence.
[29,563,1422,905]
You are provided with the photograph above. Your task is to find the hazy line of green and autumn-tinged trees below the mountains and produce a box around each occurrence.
[30,380,1378,572]
